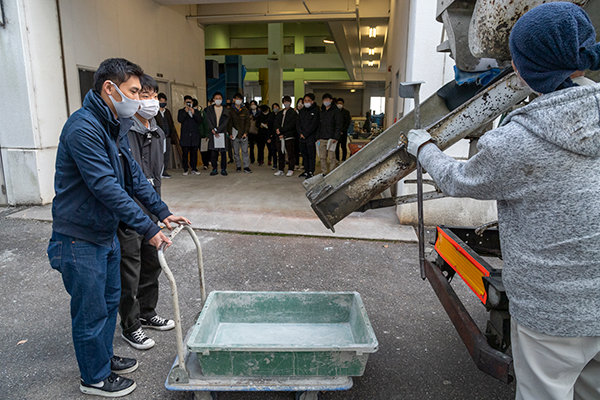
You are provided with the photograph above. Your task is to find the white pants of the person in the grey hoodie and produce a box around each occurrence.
[511,320,600,400]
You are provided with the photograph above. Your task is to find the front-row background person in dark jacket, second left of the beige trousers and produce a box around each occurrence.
[275,96,298,176]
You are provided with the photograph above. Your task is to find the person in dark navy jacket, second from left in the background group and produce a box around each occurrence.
[177,95,202,175]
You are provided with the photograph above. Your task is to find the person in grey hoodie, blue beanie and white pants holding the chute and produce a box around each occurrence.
[408,2,600,400]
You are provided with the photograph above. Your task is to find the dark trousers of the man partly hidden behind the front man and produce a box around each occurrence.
[117,228,161,333]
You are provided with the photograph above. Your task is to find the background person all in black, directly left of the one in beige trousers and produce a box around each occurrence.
[296,93,321,178]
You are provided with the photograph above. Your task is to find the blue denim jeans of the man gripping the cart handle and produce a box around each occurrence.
[48,232,121,384]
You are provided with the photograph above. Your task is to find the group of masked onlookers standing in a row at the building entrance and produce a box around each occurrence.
[166,92,351,178]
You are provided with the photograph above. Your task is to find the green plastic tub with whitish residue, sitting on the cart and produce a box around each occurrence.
[187,291,378,377]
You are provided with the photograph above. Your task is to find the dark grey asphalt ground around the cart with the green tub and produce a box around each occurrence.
[0,214,514,400]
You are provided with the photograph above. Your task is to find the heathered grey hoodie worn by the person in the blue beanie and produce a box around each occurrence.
[419,85,600,336]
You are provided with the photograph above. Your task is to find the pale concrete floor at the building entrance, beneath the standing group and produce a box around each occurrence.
[12,164,417,242]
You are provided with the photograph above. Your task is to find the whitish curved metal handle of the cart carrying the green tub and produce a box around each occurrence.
[158,224,206,383]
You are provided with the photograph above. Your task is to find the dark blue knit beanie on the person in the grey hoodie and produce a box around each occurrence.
[509,2,600,93]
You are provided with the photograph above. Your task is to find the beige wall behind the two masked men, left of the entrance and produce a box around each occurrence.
[59,0,206,112]
